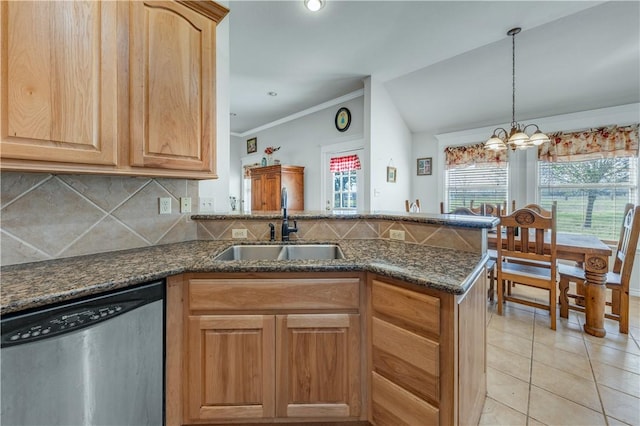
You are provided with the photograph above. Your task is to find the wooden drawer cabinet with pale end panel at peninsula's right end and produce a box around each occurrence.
[368,273,487,426]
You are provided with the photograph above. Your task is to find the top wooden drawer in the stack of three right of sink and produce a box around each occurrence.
[371,280,440,337]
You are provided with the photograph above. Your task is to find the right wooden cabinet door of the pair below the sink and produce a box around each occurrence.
[276,314,361,418]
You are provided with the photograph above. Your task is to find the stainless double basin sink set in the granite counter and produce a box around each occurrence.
[214,244,344,260]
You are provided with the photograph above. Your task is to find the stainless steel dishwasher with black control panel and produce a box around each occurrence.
[0,281,165,426]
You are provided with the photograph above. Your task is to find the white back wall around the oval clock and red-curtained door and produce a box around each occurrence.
[235,96,364,210]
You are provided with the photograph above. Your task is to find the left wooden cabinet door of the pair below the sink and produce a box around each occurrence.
[187,315,275,420]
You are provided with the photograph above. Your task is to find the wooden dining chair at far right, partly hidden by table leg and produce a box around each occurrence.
[558,204,640,334]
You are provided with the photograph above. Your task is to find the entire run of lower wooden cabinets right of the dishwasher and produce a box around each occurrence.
[166,270,486,426]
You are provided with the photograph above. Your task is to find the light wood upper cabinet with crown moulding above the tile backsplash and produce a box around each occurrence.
[0,0,228,179]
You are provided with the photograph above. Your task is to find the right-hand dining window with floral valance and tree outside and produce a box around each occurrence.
[538,124,638,241]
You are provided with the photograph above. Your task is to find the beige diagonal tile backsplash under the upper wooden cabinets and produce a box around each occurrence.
[0,172,198,265]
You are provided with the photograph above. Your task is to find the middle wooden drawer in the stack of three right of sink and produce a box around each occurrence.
[371,317,440,405]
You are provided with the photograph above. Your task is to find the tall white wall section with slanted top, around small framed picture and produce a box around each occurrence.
[365,77,415,211]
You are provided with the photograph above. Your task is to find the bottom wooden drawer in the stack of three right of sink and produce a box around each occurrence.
[371,372,440,425]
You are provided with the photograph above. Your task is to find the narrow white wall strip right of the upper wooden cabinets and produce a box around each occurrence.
[198,5,231,212]
